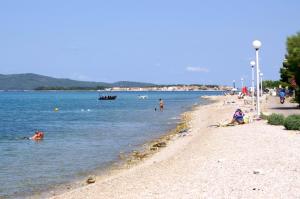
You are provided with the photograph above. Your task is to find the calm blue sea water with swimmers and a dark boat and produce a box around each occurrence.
[0,92,221,198]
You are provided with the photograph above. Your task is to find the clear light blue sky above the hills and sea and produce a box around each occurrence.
[0,0,300,85]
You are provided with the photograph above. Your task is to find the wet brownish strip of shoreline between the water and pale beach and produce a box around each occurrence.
[44,96,223,199]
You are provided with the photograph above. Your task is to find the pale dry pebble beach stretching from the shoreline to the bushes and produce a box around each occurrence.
[48,96,300,199]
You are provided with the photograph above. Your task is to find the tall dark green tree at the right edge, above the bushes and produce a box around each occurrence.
[280,32,300,103]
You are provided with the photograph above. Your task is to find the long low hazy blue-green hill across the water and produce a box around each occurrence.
[0,73,154,90]
